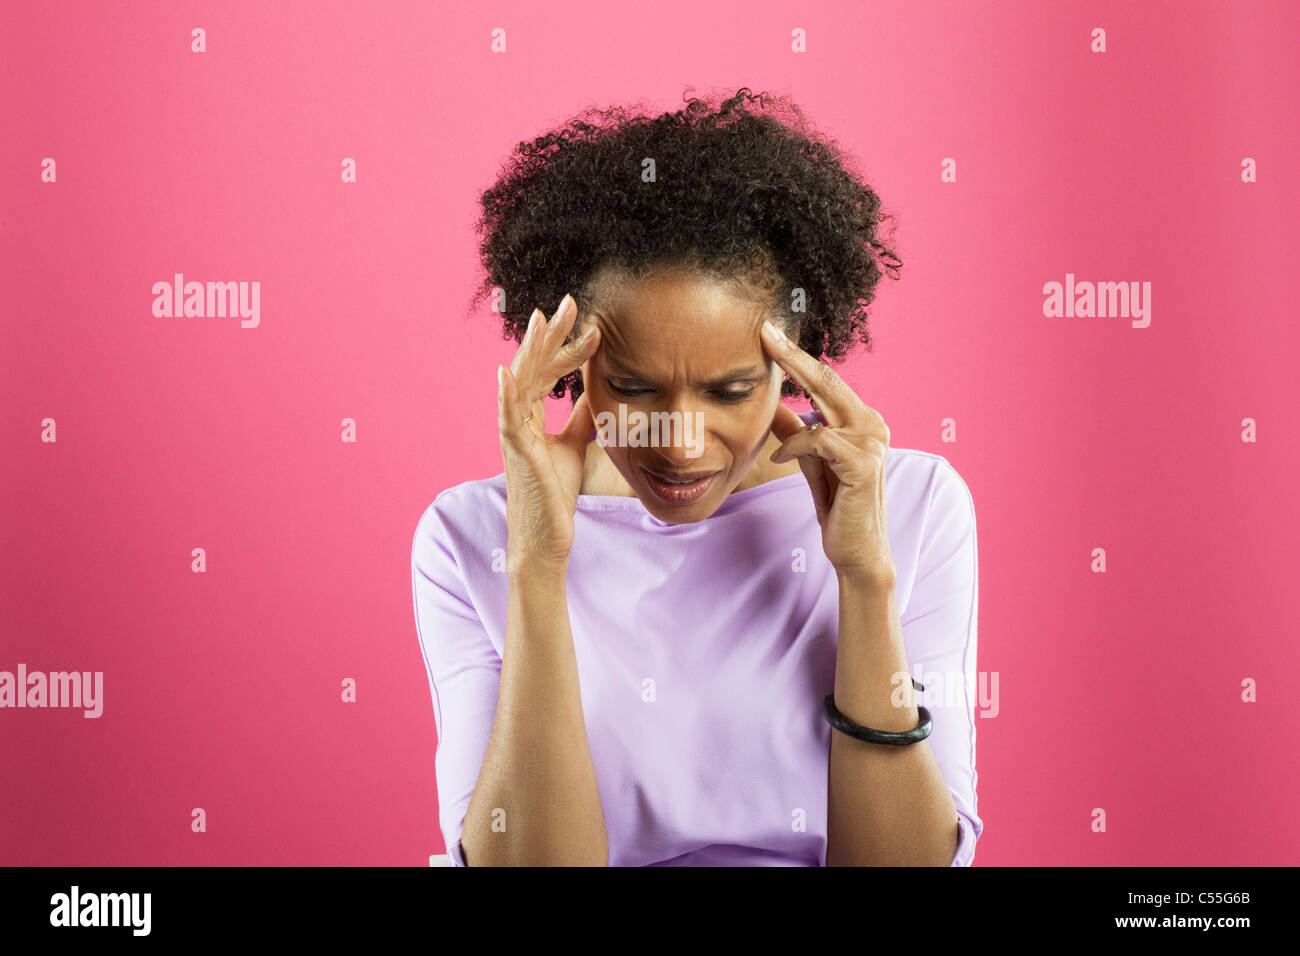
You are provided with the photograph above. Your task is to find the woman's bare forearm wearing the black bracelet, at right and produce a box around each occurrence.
[826,576,958,866]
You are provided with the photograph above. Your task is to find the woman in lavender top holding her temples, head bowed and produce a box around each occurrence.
[412,90,983,866]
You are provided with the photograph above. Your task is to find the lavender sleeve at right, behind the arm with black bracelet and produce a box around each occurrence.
[900,458,984,866]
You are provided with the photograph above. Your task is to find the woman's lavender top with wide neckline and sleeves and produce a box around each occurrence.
[411,411,984,866]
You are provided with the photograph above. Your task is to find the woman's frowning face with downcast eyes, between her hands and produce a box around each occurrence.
[582,268,785,524]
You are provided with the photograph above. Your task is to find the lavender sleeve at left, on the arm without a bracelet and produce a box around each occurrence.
[411,496,501,866]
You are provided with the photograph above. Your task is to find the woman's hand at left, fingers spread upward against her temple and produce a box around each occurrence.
[497,295,601,563]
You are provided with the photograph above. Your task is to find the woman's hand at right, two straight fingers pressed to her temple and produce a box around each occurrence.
[761,323,894,584]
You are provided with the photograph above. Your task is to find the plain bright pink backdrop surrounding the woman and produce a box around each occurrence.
[0,0,1300,865]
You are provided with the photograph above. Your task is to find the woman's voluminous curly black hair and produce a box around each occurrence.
[472,87,902,402]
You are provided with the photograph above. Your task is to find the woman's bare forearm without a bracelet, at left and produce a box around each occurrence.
[462,561,608,866]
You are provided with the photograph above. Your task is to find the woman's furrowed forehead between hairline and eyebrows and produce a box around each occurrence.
[593,269,771,375]
